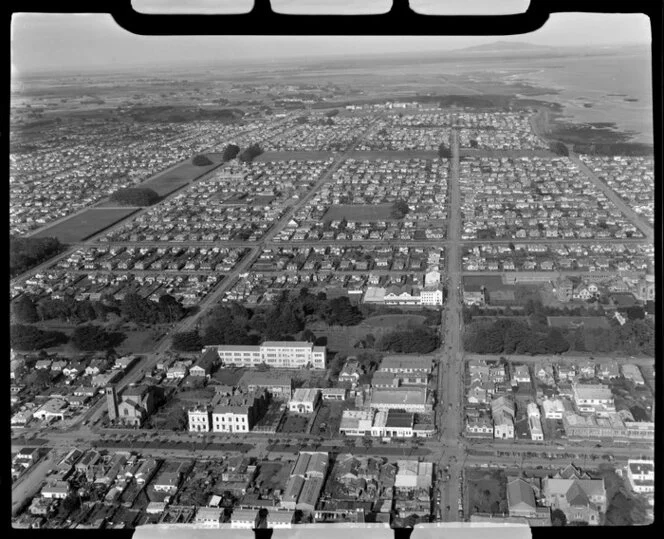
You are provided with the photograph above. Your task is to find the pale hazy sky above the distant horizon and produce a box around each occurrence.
[11,13,650,73]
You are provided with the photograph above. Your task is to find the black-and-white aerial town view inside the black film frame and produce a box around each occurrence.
[10,5,661,530]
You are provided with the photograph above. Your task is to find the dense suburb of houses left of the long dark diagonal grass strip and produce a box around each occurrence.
[10,122,238,234]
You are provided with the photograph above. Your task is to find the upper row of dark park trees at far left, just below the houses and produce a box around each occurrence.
[11,294,187,324]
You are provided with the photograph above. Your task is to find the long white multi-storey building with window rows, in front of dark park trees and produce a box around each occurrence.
[207,341,325,369]
